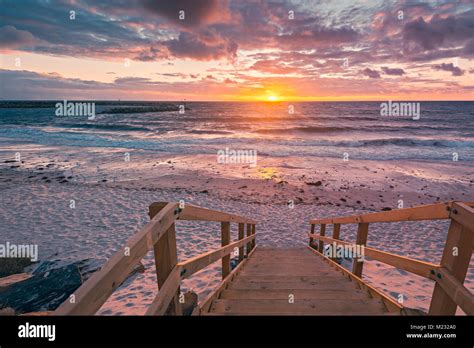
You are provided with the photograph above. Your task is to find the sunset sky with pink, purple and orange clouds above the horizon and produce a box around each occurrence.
[0,0,474,101]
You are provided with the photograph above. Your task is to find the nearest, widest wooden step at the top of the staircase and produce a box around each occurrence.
[211,299,387,315]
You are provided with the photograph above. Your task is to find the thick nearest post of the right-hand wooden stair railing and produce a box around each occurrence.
[428,220,473,315]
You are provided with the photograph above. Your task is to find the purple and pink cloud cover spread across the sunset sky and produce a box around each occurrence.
[0,0,474,98]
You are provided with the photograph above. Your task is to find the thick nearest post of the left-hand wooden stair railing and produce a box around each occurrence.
[153,224,182,315]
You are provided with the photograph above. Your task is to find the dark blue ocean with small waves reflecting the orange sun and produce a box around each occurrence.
[0,101,474,162]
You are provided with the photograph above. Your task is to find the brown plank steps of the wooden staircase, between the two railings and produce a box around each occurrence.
[206,248,388,315]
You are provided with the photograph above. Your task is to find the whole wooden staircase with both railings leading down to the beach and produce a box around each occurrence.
[53,202,474,315]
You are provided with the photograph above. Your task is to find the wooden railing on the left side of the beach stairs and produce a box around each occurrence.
[53,202,256,315]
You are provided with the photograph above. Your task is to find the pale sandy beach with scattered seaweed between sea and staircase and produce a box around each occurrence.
[0,141,474,315]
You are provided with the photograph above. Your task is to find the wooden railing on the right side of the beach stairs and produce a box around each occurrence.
[308,201,474,315]
